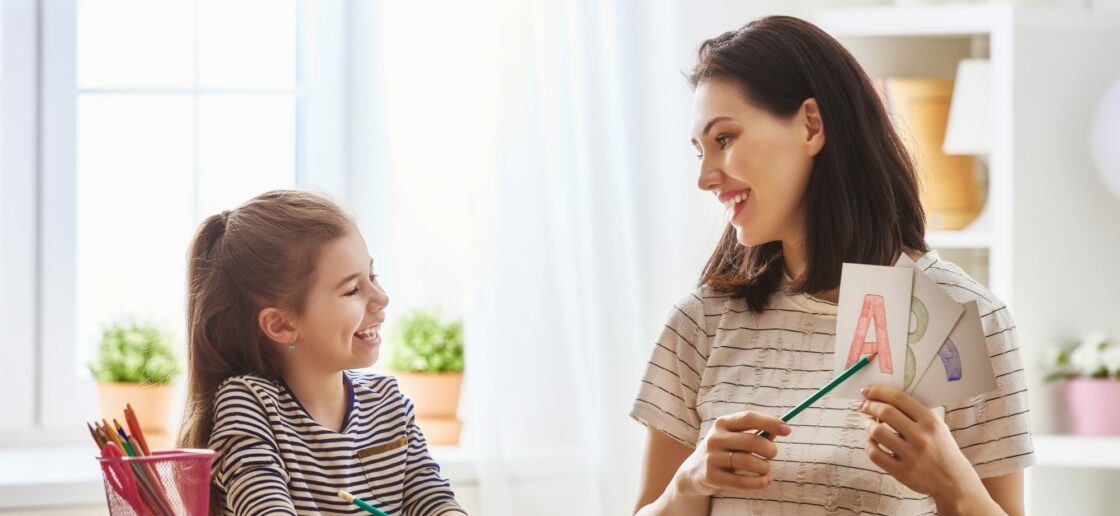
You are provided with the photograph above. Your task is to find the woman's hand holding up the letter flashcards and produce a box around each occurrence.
[859,385,1004,514]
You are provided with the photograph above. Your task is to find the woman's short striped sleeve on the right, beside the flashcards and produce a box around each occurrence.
[945,299,1035,478]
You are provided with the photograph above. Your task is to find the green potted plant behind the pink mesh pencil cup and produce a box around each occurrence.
[90,320,180,448]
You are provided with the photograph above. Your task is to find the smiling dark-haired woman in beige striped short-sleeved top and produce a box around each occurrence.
[632,17,1034,515]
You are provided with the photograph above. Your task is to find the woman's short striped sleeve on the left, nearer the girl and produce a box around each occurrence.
[631,291,709,448]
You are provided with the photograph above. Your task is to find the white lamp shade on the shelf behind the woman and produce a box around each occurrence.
[942,59,991,156]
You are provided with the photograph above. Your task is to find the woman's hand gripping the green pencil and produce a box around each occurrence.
[673,411,791,496]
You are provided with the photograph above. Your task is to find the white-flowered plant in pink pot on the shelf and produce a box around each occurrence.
[1045,334,1120,435]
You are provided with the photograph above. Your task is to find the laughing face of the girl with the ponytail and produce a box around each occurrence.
[293,229,389,372]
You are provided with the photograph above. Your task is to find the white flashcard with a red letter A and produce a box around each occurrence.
[832,263,914,397]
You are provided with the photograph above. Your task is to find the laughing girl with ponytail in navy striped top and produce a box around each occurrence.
[179,190,464,516]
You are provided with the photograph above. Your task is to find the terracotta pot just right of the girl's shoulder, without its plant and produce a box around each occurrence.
[394,373,463,445]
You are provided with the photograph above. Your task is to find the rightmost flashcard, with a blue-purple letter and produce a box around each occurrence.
[911,301,996,406]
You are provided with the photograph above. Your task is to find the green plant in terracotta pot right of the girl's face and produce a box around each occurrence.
[389,310,464,445]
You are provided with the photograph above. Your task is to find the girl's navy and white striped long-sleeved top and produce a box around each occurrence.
[209,372,463,516]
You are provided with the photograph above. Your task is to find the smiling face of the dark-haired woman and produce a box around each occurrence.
[692,78,824,245]
